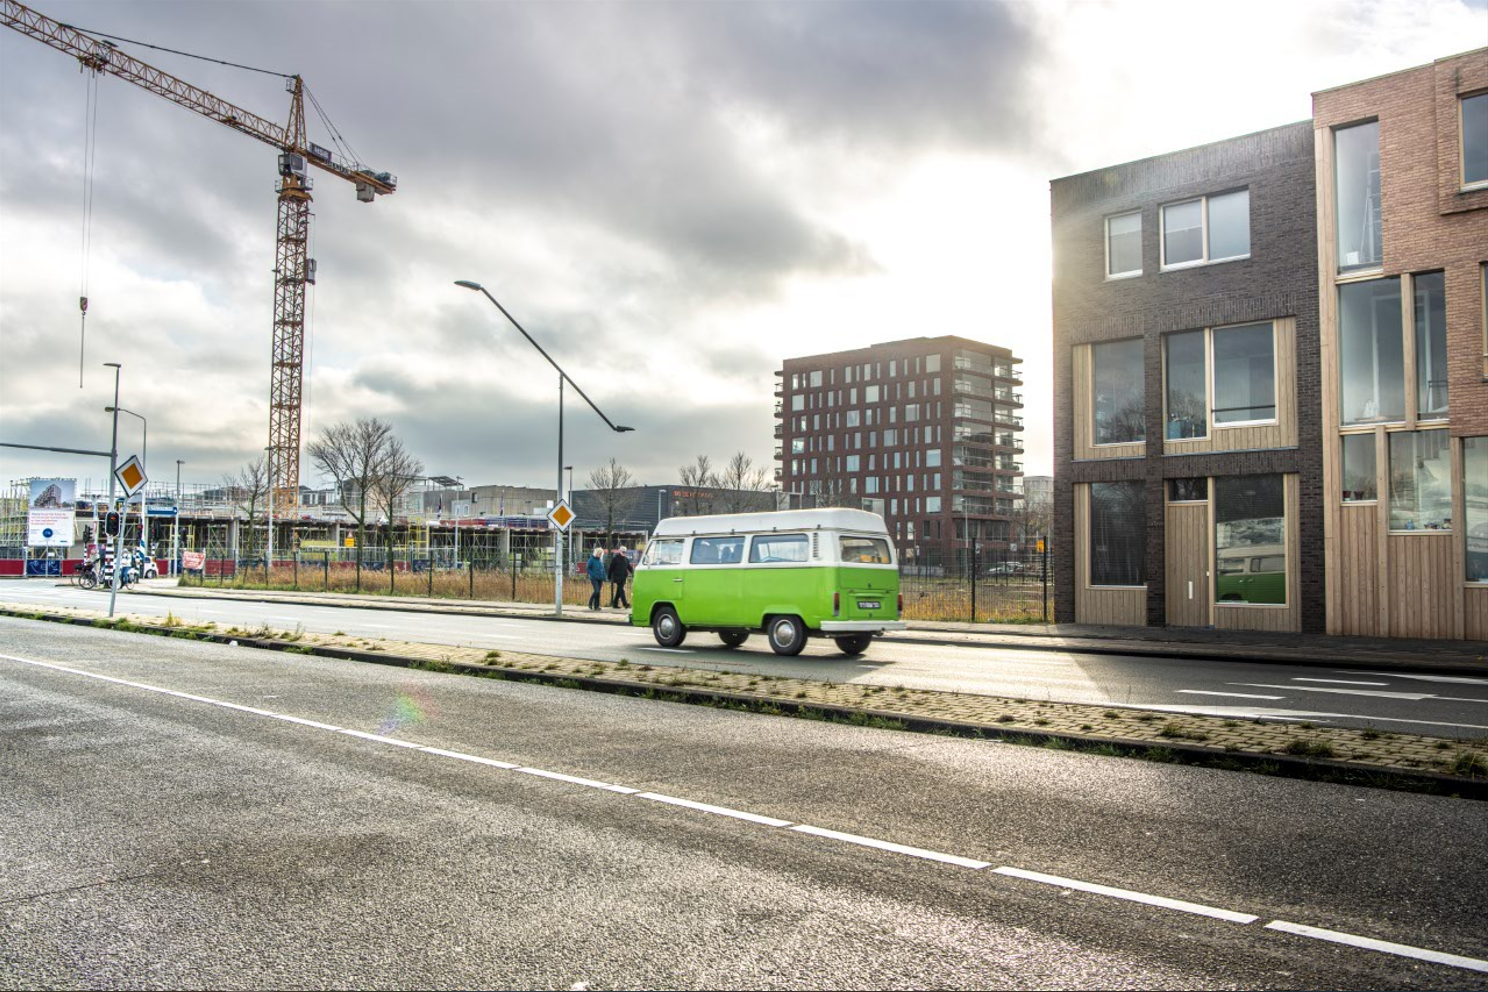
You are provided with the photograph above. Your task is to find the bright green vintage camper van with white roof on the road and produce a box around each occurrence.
[631,509,905,654]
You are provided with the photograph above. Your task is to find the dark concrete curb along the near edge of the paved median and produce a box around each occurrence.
[0,608,1488,800]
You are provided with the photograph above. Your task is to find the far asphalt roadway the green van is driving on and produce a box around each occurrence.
[0,583,1488,738]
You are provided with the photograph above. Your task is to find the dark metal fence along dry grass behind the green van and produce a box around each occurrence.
[182,549,1054,623]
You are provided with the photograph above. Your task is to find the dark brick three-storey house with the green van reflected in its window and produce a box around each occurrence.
[1052,122,1324,631]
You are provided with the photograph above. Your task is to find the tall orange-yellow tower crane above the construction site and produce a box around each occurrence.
[0,0,397,509]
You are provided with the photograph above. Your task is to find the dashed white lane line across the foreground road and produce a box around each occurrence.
[0,654,1488,971]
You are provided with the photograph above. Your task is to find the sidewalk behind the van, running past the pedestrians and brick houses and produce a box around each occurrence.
[129,580,1488,677]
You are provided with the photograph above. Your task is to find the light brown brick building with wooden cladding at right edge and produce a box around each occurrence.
[1312,49,1488,640]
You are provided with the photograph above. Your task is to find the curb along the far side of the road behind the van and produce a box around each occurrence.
[129,587,1488,675]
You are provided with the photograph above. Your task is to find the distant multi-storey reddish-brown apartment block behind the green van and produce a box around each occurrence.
[775,336,1024,570]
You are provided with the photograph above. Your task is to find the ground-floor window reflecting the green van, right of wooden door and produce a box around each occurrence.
[1214,476,1287,604]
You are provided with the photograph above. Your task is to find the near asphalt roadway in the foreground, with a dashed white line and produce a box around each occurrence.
[0,619,1488,989]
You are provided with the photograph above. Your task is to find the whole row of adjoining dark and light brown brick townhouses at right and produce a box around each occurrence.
[1052,49,1488,640]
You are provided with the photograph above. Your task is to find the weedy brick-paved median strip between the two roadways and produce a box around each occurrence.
[0,604,1488,782]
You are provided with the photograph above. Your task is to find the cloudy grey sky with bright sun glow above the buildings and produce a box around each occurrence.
[0,0,1488,496]
